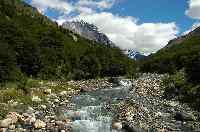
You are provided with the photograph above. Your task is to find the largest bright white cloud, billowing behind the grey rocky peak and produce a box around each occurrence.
[74,12,178,54]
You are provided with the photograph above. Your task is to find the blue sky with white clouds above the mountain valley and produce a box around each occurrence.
[25,0,200,54]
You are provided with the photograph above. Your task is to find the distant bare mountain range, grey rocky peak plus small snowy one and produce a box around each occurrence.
[62,20,145,60]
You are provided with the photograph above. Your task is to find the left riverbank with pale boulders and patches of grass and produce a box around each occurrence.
[0,79,112,132]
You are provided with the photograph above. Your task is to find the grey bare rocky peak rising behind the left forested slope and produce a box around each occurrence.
[62,20,113,46]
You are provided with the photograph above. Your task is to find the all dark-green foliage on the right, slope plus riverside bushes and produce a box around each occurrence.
[140,28,200,111]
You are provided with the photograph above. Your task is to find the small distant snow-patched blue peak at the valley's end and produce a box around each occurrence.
[124,50,146,61]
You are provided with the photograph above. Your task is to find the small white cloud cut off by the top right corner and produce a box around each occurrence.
[185,0,200,19]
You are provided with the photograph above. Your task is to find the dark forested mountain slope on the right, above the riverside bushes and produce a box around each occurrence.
[141,27,200,76]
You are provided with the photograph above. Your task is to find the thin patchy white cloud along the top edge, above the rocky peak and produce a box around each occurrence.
[31,0,116,14]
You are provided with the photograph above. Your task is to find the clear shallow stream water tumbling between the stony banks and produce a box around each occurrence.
[65,80,131,132]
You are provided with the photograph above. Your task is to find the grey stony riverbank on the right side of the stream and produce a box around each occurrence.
[117,74,200,132]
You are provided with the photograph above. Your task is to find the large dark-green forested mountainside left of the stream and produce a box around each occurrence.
[0,0,134,82]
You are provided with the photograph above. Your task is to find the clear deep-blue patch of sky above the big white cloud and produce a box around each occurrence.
[111,0,197,32]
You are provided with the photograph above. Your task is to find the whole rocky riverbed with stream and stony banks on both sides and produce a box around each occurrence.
[0,74,200,132]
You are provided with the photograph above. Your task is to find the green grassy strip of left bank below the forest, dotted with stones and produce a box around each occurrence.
[0,79,78,119]
